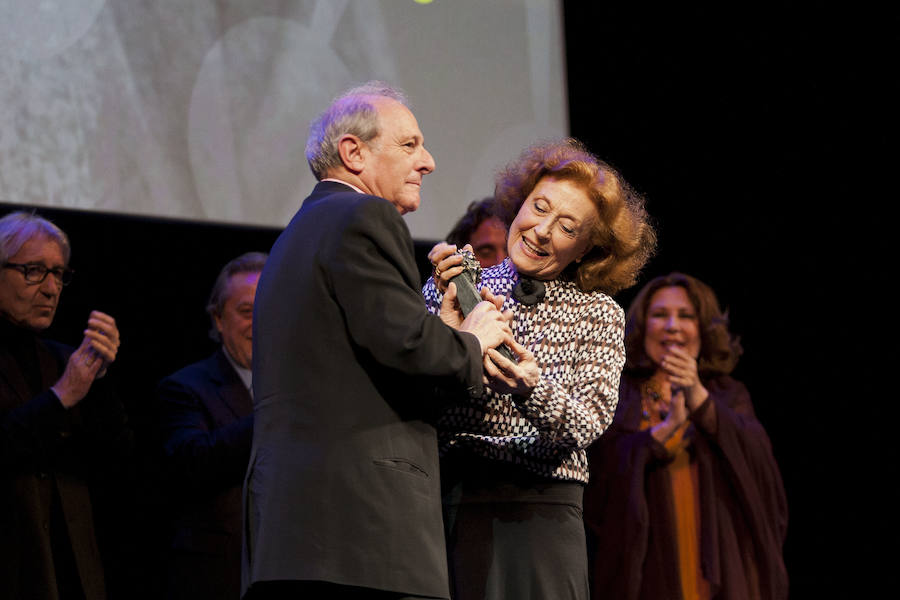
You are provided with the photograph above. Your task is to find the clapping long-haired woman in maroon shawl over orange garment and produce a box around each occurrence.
[584,273,788,600]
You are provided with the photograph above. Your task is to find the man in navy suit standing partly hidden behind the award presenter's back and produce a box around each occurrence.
[157,252,266,600]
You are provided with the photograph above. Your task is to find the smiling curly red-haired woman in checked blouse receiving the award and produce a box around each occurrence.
[423,139,656,600]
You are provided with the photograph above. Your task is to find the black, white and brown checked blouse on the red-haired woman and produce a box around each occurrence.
[422,258,625,482]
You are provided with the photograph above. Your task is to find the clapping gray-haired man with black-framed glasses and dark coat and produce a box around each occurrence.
[0,212,133,600]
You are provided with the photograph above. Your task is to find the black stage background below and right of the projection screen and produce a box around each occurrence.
[0,2,884,598]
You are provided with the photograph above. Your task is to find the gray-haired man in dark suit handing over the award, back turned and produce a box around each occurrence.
[244,82,511,598]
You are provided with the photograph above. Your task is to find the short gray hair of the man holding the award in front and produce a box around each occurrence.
[306,80,408,180]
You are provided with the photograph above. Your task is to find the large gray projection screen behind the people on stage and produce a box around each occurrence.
[0,0,568,239]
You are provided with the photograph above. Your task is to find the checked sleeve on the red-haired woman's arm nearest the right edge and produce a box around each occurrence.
[513,296,625,449]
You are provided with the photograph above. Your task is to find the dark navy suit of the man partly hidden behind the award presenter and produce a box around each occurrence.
[157,348,253,600]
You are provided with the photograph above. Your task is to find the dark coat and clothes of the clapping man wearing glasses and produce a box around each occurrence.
[0,322,134,600]
